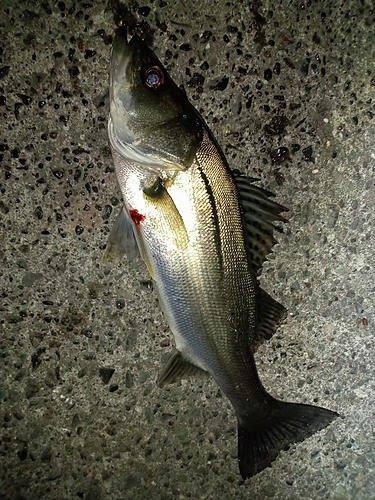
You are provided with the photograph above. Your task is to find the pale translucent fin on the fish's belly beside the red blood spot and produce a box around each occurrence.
[102,208,140,262]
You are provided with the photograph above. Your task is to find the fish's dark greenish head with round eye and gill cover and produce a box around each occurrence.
[108,27,203,171]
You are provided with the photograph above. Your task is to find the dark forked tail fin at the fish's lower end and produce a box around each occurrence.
[238,400,338,479]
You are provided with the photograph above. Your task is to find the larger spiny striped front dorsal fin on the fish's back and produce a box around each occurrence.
[233,171,288,278]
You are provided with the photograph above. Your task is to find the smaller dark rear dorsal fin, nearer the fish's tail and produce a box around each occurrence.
[251,287,286,350]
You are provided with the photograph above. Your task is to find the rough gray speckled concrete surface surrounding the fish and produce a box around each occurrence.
[0,0,375,500]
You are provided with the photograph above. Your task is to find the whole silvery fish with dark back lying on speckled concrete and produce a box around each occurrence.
[104,26,338,479]
